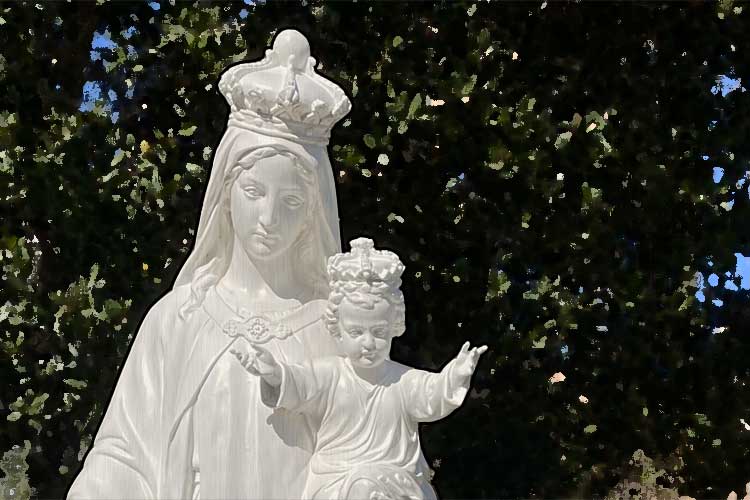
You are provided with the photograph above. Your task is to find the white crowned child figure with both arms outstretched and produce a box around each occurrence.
[233,238,487,500]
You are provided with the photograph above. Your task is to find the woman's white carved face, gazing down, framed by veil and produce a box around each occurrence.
[230,156,310,259]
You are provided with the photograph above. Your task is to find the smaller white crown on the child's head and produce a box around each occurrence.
[328,238,405,287]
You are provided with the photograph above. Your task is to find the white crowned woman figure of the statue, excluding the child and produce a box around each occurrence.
[67,30,351,500]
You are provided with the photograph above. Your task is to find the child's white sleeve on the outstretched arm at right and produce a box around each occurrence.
[405,359,471,422]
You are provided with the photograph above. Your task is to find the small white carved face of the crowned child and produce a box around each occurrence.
[338,299,392,368]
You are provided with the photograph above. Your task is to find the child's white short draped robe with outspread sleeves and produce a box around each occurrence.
[263,357,469,500]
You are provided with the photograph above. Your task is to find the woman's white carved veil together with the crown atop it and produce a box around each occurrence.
[175,30,351,299]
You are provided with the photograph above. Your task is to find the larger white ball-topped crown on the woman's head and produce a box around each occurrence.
[219,30,352,145]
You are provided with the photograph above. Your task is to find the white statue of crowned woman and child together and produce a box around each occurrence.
[67,30,486,500]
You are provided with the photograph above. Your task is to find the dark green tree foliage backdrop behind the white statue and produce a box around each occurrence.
[0,0,750,498]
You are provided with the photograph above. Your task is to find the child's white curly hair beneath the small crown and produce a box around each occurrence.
[324,280,406,337]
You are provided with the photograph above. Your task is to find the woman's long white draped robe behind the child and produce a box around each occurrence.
[67,286,336,500]
